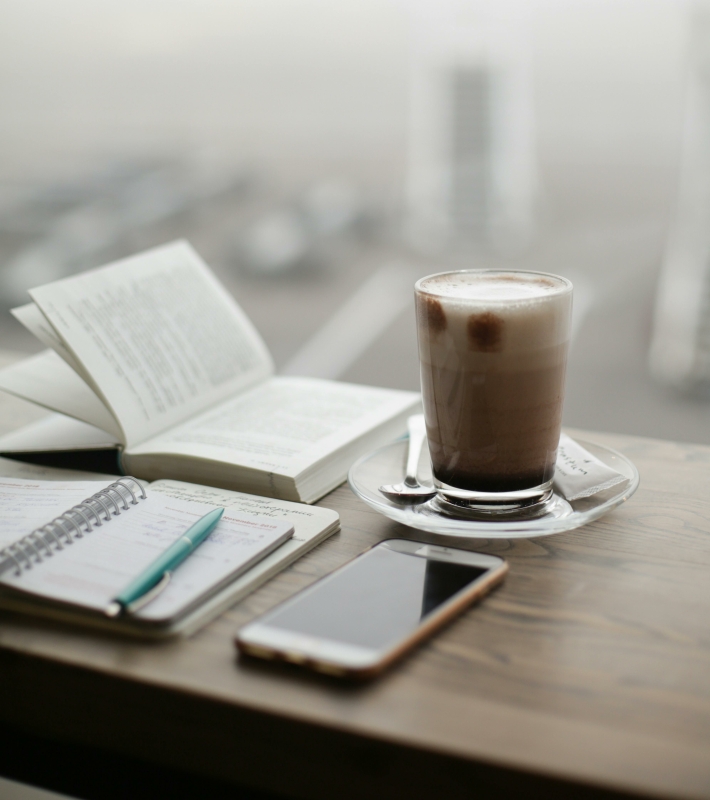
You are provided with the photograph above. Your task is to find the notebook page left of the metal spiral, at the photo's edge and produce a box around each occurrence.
[0,476,114,547]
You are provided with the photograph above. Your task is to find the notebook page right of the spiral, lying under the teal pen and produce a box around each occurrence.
[0,494,293,620]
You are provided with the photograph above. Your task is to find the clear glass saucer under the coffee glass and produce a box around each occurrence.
[348,439,639,539]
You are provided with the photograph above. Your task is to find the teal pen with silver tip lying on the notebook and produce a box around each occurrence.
[106,508,224,617]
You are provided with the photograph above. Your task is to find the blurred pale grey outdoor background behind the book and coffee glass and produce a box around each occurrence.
[0,0,710,443]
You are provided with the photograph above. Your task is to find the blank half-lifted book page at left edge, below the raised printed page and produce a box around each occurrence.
[0,350,125,443]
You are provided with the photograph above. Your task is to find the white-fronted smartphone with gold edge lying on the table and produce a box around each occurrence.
[236,539,508,678]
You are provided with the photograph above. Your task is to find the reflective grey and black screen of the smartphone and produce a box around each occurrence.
[261,547,487,650]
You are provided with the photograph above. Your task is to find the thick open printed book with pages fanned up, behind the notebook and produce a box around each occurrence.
[0,242,419,503]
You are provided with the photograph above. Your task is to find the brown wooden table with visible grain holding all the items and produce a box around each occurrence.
[0,376,710,798]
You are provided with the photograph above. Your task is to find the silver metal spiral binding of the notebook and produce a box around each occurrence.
[0,475,147,575]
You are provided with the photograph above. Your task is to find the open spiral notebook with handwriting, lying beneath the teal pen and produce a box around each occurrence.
[0,477,294,635]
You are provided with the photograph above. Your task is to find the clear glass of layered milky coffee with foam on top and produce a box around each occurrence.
[415,270,572,516]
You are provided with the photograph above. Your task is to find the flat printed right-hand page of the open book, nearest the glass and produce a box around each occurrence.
[130,377,419,477]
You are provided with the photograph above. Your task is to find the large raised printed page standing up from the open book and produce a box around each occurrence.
[30,242,273,445]
